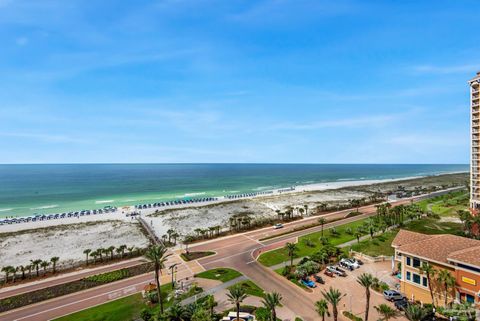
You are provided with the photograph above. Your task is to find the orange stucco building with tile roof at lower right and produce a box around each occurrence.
[392,230,480,307]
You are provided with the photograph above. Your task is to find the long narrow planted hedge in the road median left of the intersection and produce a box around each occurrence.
[0,263,154,313]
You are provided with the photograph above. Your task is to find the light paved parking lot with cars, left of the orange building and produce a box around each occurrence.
[313,261,407,320]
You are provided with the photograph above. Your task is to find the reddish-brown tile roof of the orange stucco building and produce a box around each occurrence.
[392,230,480,266]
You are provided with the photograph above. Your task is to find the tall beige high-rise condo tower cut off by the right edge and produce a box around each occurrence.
[469,71,480,212]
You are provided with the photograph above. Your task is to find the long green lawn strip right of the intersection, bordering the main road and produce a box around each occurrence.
[258,219,367,266]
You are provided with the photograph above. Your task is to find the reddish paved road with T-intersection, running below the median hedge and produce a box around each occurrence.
[0,189,462,321]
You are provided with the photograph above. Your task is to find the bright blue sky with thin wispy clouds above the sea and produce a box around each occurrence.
[0,0,480,163]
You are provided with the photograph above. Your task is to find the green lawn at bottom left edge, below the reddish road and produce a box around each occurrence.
[55,293,145,321]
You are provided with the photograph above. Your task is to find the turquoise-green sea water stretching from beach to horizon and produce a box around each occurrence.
[0,164,469,217]
